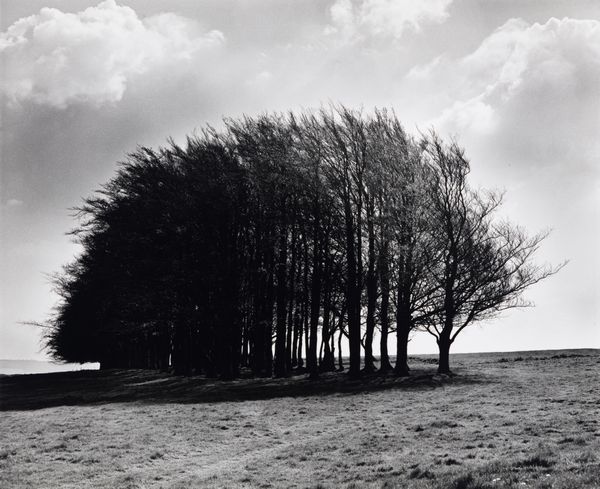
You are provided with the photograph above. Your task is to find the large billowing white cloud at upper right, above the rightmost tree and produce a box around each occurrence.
[420,18,600,157]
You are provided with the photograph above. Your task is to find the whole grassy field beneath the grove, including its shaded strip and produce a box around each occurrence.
[0,350,600,489]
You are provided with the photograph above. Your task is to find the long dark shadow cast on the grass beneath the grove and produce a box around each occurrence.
[0,369,490,411]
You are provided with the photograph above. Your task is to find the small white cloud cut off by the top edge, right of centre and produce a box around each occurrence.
[326,0,452,40]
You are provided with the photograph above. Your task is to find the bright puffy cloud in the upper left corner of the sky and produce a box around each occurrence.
[0,0,224,108]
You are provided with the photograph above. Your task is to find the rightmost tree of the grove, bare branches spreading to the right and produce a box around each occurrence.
[424,133,563,374]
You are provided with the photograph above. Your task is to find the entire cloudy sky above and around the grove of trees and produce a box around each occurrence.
[0,0,600,359]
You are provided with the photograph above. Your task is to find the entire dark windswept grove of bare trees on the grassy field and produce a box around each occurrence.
[46,107,556,378]
